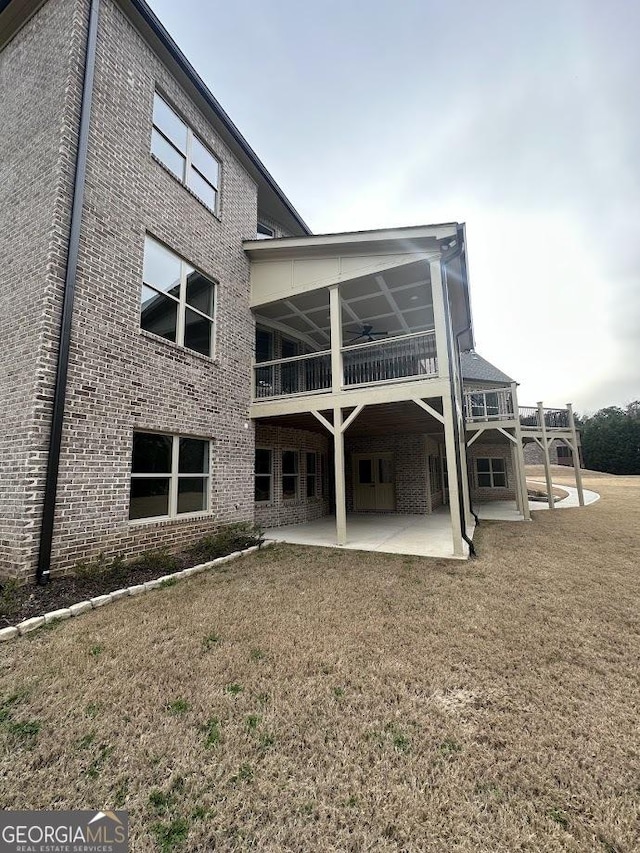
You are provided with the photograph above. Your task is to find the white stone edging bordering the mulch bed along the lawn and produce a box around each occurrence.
[0,539,276,643]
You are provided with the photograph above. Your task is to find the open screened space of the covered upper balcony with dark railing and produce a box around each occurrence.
[253,262,438,402]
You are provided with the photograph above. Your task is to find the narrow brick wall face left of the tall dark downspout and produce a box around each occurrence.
[0,0,88,575]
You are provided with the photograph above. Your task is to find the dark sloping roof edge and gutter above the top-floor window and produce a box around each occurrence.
[129,0,312,235]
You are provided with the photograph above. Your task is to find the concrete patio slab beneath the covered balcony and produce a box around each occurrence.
[264,507,473,559]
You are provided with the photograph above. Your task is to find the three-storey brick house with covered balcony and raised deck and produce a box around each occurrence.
[0,0,577,581]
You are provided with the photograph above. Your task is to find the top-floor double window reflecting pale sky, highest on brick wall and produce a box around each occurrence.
[151,92,220,213]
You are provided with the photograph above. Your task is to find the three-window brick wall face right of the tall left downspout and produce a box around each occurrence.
[40,0,266,570]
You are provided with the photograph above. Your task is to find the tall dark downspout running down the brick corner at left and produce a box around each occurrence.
[36,0,100,586]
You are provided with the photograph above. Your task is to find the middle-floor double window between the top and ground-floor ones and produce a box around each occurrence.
[140,235,216,356]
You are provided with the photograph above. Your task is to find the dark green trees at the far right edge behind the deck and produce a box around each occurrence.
[576,400,640,474]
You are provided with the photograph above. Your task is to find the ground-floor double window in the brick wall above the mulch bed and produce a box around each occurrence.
[129,432,210,519]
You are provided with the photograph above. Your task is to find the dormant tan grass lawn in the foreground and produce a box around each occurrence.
[0,469,640,853]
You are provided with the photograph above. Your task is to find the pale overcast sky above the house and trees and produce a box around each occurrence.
[151,0,640,412]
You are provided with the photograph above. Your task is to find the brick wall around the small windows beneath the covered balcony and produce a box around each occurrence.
[252,424,329,528]
